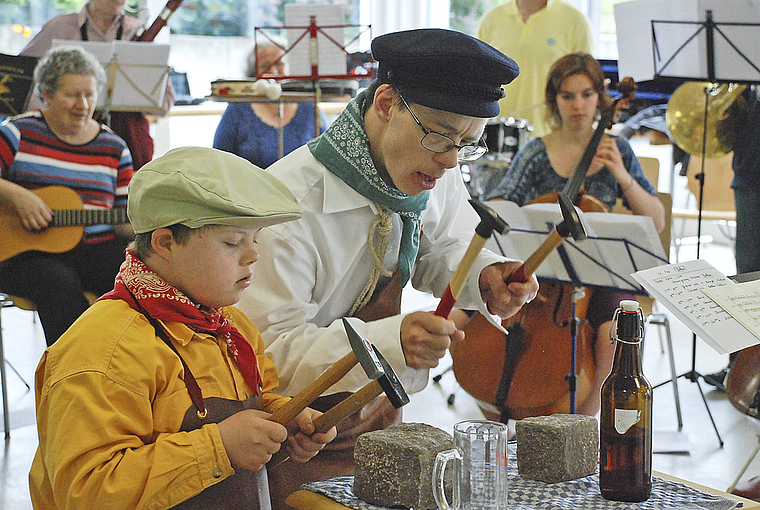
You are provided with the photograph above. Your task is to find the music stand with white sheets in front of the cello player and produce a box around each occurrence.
[487,200,667,414]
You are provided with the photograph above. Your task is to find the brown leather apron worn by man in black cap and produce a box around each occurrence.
[269,271,401,510]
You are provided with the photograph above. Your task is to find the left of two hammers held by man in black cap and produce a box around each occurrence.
[435,199,509,317]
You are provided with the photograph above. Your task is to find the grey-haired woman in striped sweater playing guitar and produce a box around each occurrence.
[0,46,133,345]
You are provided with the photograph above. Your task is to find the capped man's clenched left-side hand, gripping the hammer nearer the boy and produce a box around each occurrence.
[401,312,464,369]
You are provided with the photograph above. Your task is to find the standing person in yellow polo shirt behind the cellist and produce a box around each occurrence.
[478,0,593,136]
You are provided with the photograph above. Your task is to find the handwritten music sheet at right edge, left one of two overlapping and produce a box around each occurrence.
[633,260,758,354]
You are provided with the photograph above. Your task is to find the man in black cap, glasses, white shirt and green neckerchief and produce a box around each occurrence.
[240,29,538,508]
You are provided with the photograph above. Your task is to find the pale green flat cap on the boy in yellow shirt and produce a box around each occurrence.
[127,147,301,234]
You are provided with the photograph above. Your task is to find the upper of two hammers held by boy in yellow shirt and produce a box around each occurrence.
[270,317,384,429]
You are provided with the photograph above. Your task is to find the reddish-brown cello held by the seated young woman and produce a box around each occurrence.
[450,78,635,422]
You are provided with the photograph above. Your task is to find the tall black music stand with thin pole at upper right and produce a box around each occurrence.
[651,9,760,448]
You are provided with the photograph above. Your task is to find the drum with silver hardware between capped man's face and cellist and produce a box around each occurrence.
[461,117,533,199]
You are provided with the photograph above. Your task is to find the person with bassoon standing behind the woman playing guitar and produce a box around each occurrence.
[20,0,174,170]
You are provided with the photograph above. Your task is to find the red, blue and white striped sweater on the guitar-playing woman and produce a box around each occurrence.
[0,111,133,244]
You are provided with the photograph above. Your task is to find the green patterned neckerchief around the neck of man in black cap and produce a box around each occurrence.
[307,92,430,286]
